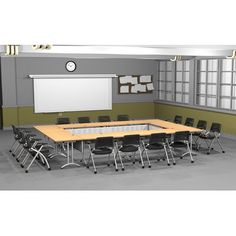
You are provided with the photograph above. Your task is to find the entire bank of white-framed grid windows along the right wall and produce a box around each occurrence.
[158,58,236,115]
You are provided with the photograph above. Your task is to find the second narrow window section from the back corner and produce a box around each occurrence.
[175,61,189,103]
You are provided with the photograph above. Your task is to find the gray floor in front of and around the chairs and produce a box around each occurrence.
[0,131,236,190]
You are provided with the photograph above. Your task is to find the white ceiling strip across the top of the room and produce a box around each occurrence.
[0,45,236,59]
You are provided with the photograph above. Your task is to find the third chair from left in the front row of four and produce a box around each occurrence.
[142,133,176,167]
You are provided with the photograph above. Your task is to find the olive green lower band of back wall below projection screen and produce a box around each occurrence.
[3,102,155,128]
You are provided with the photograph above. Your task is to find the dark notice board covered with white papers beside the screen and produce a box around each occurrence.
[118,75,154,94]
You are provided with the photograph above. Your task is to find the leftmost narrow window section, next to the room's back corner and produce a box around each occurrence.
[158,61,174,101]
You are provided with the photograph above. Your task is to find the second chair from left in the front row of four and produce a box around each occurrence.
[116,134,144,170]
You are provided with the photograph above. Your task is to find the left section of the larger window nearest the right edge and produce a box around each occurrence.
[196,59,218,107]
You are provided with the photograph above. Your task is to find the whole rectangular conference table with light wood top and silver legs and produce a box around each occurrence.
[34,119,202,168]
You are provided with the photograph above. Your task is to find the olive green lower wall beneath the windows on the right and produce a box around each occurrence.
[155,103,236,135]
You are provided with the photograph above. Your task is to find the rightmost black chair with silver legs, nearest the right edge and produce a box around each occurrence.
[197,122,225,155]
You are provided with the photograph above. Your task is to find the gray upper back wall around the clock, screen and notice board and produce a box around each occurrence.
[1,56,157,107]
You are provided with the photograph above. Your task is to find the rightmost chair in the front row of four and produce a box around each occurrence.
[170,131,194,163]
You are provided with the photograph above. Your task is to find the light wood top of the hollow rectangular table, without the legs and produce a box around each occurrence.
[34,119,201,142]
